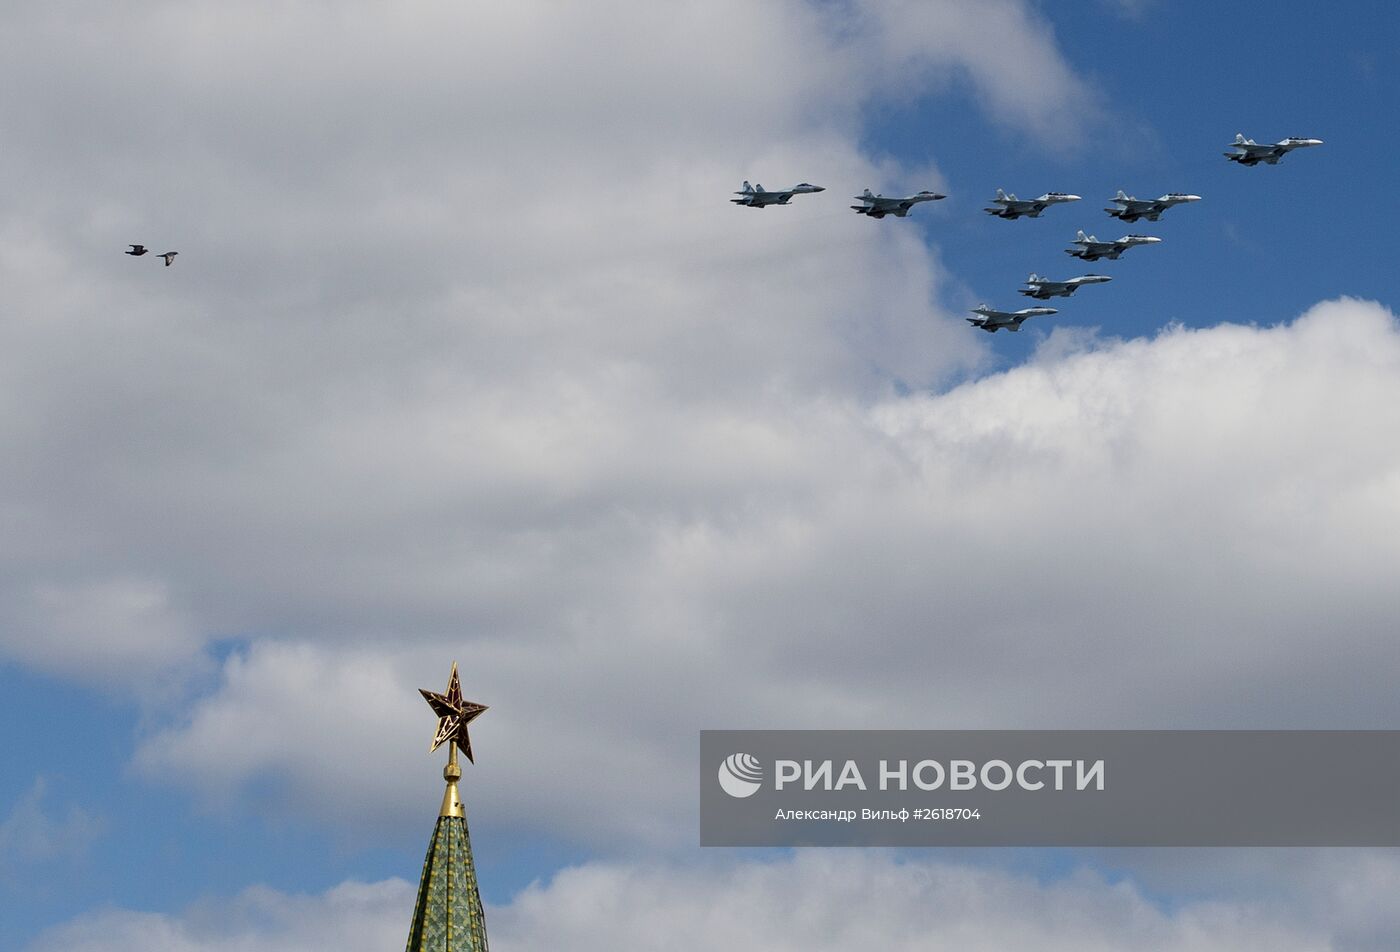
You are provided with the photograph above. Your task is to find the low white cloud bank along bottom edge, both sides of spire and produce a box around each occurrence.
[28,851,1377,952]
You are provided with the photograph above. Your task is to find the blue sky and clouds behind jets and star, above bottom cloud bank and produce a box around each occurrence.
[0,0,1400,952]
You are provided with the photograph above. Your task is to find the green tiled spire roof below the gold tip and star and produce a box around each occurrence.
[406,816,487,952]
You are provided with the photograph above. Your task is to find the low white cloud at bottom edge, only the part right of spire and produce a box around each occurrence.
[498,853,1319,952]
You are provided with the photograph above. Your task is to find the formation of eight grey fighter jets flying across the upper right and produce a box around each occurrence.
[733,133,1322,333]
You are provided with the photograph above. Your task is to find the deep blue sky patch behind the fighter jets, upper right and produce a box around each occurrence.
[868,3,1400,361]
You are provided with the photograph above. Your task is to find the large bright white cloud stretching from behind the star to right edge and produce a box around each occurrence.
[139,301,1400,848]
